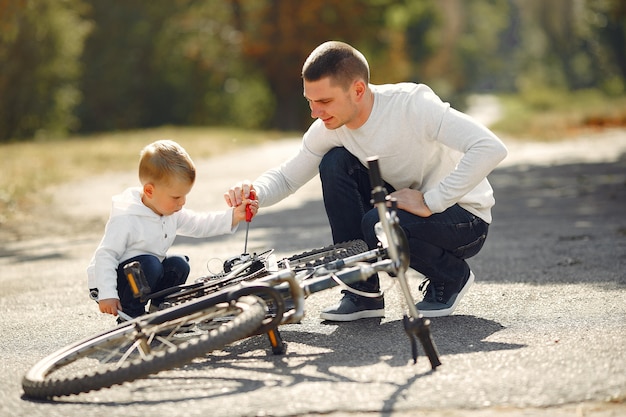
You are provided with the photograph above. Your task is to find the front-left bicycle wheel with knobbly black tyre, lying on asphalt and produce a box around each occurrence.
[22,296,266,399]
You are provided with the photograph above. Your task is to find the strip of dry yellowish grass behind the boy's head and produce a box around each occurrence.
[0,127,298,227]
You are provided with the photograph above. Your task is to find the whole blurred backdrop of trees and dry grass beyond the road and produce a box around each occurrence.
[0,0,626,234]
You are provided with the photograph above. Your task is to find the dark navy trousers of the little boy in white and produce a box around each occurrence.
[117,255,191,317]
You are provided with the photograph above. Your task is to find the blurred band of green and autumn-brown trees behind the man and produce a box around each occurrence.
[0,0,626,141]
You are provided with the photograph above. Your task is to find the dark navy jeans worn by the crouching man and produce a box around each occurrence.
[319,148,489,292]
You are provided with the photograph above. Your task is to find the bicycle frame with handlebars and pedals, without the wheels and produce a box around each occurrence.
[122,157,441,370]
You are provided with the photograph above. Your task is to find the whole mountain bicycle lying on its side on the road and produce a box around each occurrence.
[22,158,441,399]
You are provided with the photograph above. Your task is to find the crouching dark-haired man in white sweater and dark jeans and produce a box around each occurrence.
[224,41,507,321]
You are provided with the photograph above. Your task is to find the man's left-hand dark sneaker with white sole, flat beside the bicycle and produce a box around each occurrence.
[320,291,385,321]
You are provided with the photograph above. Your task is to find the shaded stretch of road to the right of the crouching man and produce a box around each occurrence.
[469,157,626,287]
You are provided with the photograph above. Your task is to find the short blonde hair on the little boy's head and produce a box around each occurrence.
[139,140,196,185]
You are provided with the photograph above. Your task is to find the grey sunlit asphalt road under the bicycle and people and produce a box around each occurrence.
[0,131,626,417]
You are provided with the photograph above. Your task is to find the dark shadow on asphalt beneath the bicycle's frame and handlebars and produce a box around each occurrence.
[128,316,524,399]
